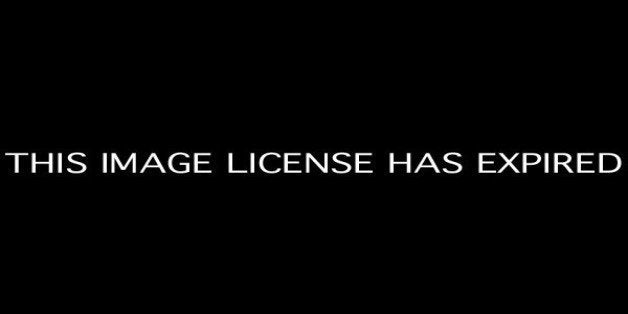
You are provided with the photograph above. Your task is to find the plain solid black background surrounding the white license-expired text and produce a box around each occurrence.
[0,3,626,309]
